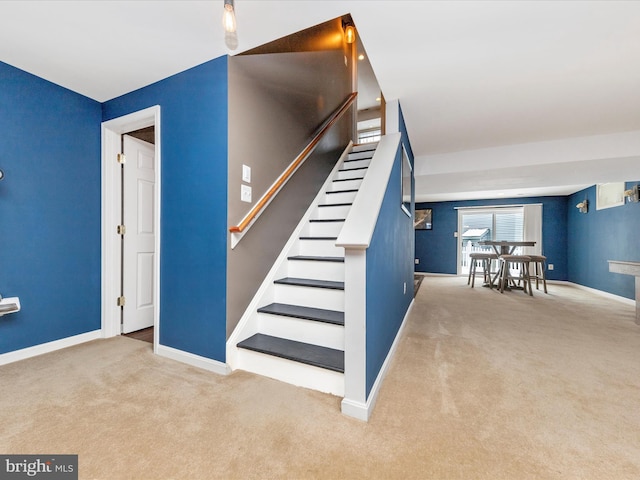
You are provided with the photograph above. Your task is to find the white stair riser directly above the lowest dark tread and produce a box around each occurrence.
[258,313,344,350]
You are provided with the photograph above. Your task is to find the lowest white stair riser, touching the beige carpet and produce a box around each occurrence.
[238,348,344,397]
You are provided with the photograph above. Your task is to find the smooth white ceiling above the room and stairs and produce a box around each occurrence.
[0,0,640,200]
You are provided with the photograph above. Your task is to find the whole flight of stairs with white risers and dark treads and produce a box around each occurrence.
[232,144,377,396]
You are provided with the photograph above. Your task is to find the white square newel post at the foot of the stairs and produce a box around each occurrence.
[342,248,369,421]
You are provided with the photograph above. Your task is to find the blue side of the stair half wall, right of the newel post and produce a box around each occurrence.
[366,106,414,397]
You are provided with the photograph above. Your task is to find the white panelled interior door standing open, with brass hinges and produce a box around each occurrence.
[122,135,157,333]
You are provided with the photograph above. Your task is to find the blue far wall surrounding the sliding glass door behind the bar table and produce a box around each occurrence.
[415,196,569,280]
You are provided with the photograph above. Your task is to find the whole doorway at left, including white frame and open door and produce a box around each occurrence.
[102,106,161,351]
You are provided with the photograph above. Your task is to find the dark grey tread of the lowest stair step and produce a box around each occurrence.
[238,333,344,373]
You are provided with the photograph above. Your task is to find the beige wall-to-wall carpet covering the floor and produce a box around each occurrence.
[0,277,640,479]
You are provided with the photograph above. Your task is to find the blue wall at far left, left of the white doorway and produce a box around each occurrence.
[0,62,101,353]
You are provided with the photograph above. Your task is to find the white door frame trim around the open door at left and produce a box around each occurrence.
[101,105,162,352]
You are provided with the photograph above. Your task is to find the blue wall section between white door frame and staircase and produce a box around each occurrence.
[103,57,228,362]
